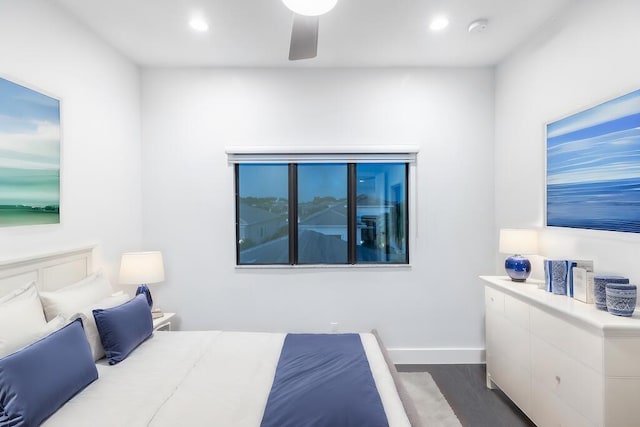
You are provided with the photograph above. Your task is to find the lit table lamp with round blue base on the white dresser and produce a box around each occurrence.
[499,228,538,282]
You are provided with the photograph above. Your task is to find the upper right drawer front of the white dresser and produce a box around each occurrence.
[530,307,603,373]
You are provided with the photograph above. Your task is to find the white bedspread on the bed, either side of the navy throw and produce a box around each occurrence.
[43,331,409,427]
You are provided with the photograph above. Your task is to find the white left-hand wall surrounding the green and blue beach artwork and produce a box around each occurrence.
[0,0,141,279]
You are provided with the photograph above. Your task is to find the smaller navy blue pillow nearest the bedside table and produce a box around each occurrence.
[93,294,153,365]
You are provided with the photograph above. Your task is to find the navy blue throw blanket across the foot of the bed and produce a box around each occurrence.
[261,334,389,427]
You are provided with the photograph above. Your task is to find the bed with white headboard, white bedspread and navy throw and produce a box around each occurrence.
[0,247,418,427]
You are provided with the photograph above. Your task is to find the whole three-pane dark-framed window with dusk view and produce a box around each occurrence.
[235,162,409,265]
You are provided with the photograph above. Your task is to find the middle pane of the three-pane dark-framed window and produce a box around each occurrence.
[298,164,348,264]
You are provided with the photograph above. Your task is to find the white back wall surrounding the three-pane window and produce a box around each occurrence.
[142,69,495,363]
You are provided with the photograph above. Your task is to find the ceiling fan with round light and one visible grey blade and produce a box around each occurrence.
[282,0,338,61]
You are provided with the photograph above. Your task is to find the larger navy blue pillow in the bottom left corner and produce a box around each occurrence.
[0,319,98,426]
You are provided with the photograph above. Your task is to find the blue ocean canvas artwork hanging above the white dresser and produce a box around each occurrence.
[547,90,640,233]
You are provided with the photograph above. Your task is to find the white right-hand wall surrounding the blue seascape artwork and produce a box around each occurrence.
[493,0,640,284]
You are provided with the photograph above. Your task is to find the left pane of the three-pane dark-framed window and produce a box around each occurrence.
[237,164,289,264]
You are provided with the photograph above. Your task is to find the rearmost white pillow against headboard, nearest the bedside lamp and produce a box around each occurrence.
[40,271,113,320]
